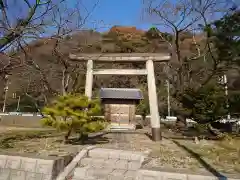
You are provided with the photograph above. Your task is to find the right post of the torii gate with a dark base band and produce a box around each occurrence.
[146,59,161,141]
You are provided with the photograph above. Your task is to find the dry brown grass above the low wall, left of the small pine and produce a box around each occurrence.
[0,128,81,156]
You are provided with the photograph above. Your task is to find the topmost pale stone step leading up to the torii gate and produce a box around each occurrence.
[88,148,146,163]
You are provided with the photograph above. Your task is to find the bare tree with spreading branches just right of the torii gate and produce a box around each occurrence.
[144,0,231,92]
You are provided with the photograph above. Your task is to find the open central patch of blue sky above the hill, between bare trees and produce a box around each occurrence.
[78,0,151,31]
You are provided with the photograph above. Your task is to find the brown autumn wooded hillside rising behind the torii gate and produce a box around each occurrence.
[1,17,239,117]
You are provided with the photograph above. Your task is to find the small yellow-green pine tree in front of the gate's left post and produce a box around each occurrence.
[42,94,106,140]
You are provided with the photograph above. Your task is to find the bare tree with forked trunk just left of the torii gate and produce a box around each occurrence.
[19,0,99,98]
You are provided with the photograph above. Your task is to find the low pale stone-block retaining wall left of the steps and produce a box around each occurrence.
[0,155,73,180]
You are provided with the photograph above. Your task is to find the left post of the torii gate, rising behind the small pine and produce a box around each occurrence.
[85,60,93,99]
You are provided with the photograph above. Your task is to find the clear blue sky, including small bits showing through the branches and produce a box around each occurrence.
[9,0,240,34]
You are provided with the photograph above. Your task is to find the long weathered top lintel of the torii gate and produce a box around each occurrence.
[69,53,171,62]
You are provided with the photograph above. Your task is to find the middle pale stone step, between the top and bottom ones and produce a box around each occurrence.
[79,157,142,171]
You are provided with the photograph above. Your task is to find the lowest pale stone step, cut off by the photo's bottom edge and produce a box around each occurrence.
[72,166,136,180]
